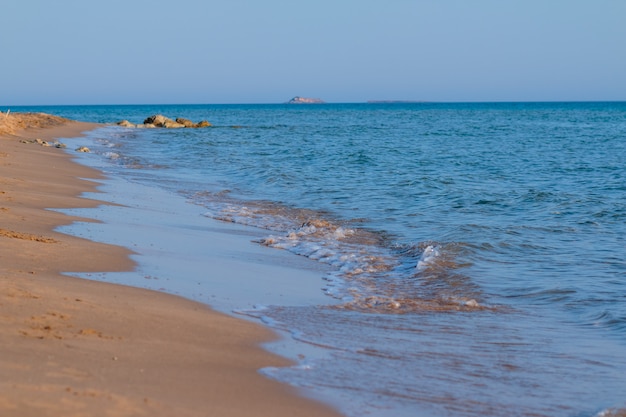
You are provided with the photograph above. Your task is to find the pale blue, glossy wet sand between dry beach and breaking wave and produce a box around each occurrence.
[54,154,338,316]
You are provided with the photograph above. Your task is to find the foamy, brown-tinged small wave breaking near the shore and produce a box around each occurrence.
[191,191,494,314]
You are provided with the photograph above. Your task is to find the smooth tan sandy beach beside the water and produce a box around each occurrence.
[0,113,338,417]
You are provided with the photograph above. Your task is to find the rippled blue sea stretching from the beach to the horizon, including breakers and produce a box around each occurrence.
[12,102,626,417]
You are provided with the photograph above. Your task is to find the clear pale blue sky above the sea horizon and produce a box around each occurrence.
[0,0,626,106]
